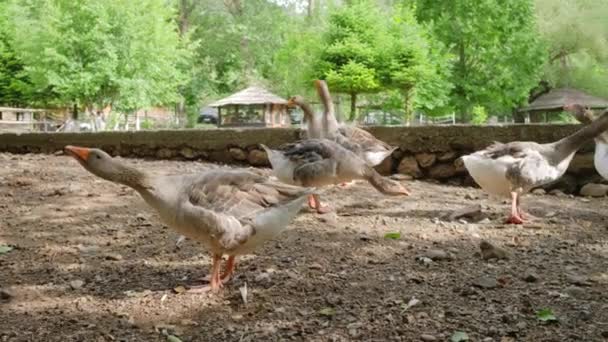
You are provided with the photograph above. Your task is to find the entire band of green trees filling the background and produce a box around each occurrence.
[0,0,608,123]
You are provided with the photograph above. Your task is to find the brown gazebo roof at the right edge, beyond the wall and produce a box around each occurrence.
[519,88,608,112]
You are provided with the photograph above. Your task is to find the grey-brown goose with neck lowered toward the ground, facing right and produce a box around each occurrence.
[262,139,409,214]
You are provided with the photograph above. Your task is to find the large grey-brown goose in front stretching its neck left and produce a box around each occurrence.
[65,146,313,291]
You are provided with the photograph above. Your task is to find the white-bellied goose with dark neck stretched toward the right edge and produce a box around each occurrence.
[462,111,608,224]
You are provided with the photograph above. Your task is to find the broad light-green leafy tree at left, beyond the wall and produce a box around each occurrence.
[10,0,182,119]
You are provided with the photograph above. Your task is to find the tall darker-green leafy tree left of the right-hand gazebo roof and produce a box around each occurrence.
[416,0,546,122]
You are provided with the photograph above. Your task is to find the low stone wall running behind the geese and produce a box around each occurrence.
[0,124,601,193]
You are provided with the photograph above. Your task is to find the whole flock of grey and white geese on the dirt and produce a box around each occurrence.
[65,81,608,292]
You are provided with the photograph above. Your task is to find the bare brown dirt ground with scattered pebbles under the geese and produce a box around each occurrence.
[0,154,608,342]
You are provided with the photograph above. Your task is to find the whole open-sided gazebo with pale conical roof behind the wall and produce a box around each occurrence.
[209,86,291,127]
